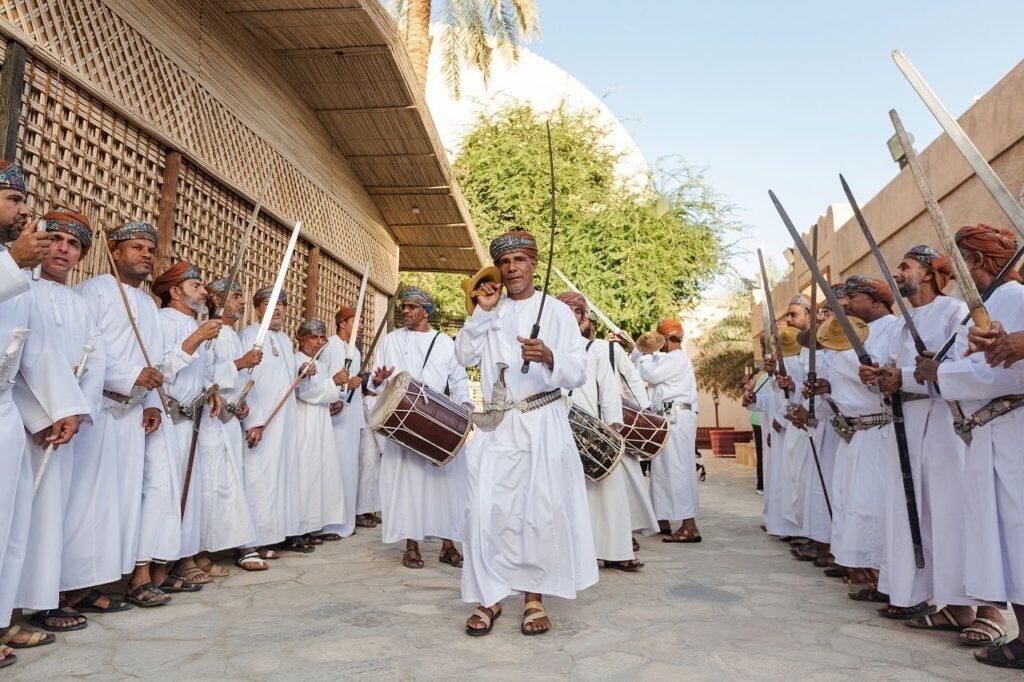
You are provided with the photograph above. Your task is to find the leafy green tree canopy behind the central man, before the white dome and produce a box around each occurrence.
[406,103,738,333]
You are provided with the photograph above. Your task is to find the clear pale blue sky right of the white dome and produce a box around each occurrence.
[520,0,1024,280]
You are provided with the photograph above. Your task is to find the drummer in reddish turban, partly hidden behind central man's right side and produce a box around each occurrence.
[558,292,643,571]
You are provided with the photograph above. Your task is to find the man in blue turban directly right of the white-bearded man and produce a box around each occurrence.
[202,279,267,578]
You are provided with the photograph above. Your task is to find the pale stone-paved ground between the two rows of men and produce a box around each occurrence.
[6,458,1022,682]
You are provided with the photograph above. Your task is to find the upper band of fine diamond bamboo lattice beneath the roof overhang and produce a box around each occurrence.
[0,0,398,289]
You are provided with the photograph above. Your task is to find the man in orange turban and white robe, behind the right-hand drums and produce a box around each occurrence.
[637,318,700,543]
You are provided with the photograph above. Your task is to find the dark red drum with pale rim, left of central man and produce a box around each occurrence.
[368,372,472,467]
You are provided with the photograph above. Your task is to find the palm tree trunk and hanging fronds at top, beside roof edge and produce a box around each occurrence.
[390,0,541,99]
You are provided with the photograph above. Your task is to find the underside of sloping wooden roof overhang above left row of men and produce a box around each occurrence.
[222,0,484,272]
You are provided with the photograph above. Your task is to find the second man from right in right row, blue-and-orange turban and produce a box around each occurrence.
[861,245,975,629]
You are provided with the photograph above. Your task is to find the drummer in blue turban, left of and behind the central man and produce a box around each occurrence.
[372,288,473,568]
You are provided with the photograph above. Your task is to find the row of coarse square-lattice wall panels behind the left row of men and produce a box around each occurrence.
[16,49,376,335]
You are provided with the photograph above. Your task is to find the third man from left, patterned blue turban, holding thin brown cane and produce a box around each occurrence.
[76,221,169,606]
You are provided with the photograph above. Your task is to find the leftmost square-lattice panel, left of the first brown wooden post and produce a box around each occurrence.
[16,57,164,284]
